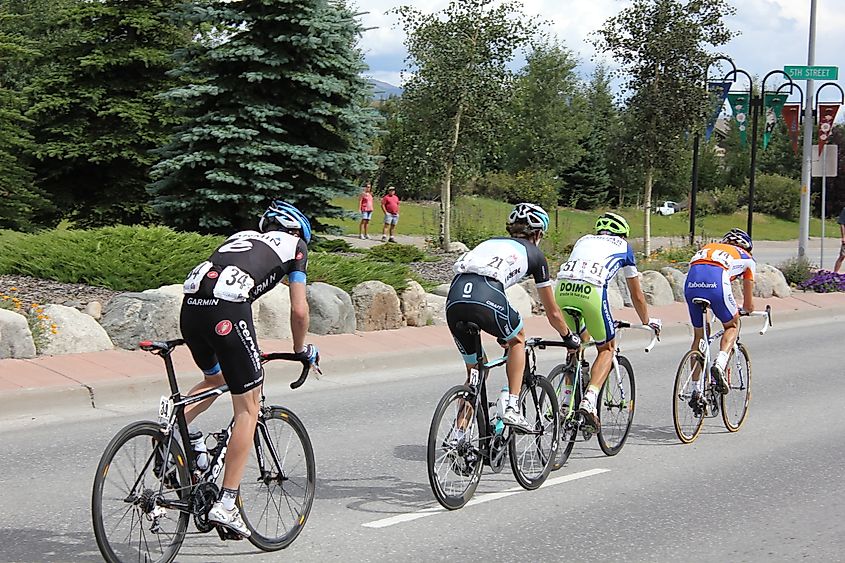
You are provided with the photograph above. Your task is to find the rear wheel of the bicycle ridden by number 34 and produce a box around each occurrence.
[91,421,191,563]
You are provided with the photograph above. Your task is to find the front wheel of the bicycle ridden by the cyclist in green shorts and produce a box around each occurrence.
[596,356,637,456]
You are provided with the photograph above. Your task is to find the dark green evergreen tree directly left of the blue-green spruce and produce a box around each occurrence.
[26,0,192,226]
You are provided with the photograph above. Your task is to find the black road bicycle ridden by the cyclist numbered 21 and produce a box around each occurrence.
[426,322,562,510]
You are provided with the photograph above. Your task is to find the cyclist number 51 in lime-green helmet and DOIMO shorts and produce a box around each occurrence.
[555,213,660,430]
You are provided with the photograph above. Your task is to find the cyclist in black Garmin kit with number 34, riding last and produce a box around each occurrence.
[180,201,318,537]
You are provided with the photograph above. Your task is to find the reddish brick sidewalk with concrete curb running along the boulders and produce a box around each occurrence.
[0,293,845,417]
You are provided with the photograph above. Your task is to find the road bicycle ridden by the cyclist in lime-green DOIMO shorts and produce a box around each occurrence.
[546,307,658,470]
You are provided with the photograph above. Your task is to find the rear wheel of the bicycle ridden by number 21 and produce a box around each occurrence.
[426,385,484,510]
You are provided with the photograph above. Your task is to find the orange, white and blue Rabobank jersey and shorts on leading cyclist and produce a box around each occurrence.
[684,243,755,328]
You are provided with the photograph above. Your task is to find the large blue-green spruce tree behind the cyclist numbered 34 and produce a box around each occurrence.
[150,0,377,233]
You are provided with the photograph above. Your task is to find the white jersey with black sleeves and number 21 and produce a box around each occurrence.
[452,237,552,289]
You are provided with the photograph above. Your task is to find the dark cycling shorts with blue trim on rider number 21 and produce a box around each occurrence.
[446,274,522,364]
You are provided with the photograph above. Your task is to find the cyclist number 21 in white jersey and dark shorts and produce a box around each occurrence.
[446,203,581,431]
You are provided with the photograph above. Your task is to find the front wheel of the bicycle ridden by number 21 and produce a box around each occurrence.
[508,376,560,491]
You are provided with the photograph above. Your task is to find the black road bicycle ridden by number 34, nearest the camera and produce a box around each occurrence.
[91,339,319,563]
